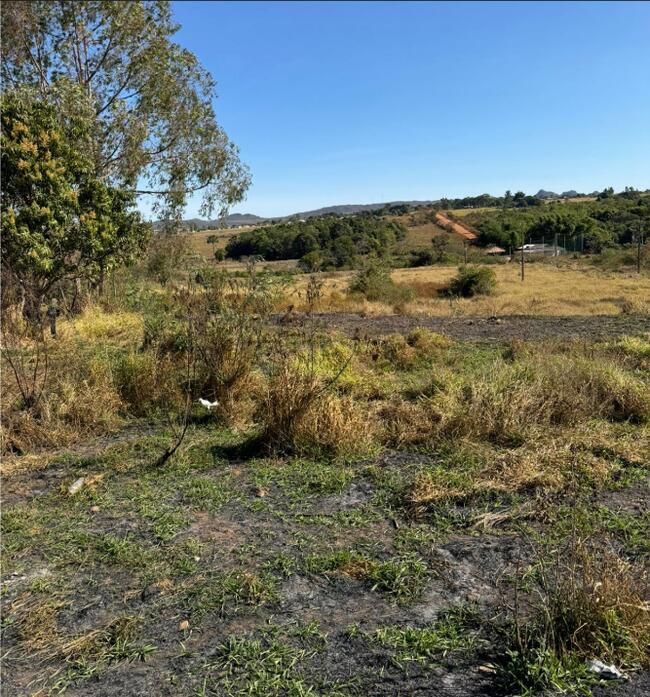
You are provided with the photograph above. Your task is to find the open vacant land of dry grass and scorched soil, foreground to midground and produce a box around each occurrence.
[2,265,650,697]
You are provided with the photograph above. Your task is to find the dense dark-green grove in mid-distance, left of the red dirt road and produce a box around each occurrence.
[226,215,405,270]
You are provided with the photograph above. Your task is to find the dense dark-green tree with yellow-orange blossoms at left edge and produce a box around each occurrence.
[0,92,149,317]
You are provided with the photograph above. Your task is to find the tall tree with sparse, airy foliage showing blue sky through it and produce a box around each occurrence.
[2,0,250,216]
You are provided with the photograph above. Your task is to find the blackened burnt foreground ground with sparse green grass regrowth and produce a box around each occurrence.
[2,431,650,697]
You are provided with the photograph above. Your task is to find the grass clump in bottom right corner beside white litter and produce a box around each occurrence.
[497,539,650,695]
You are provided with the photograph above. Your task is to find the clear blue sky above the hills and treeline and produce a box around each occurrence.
[168,2,650,217]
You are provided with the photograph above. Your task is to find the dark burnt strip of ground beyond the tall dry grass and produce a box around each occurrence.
[277,313,650,342]
